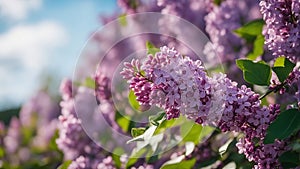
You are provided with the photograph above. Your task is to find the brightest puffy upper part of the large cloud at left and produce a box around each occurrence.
[0,22,66,69]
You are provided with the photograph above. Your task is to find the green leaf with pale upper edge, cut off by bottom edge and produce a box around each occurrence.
[161,156,196,169]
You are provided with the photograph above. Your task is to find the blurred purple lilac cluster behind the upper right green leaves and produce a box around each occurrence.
[205,0,259,61]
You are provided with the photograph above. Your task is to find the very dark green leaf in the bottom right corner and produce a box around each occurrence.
[279,151,300,168]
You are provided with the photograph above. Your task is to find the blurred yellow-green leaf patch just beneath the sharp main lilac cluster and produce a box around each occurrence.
[180,121,202,144]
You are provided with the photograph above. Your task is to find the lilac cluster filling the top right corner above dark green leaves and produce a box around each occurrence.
[259,0,300,60]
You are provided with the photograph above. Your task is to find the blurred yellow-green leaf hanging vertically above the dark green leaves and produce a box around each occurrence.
[247,35,265,60]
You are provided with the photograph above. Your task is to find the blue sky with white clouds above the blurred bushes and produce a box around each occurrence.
[0,0,117,109]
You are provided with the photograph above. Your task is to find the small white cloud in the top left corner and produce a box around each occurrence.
[0,0,42,20]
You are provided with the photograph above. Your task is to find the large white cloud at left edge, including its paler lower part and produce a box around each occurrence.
[0,21,67,107]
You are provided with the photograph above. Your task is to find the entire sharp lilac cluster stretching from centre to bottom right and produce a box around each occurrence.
[121,46,284,168]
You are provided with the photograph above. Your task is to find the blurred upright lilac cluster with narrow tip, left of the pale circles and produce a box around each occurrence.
[56,80,102,160]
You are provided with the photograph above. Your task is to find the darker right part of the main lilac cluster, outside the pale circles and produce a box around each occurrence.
[210,76,285,168]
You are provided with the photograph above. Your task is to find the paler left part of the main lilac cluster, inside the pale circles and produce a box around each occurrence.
[121,46,211,121]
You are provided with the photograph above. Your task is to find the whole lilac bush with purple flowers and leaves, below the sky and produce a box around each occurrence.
[0,0,300,169]
